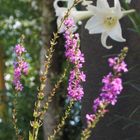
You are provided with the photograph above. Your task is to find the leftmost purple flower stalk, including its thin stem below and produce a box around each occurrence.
[12,36,29,140]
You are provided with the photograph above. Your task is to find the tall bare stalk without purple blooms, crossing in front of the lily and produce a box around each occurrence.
[29,0,80,140]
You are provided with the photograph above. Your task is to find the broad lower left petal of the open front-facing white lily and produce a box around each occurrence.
[85,16,105,34]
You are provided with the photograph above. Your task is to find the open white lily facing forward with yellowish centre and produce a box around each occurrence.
[85,0,135,49]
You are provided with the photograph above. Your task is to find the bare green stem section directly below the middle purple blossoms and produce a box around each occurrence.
[48,100,74,140]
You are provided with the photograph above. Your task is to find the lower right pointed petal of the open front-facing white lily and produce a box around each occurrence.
[108,21,126,42]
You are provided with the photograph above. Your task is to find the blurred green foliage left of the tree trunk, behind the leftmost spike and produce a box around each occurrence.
[0,0,41,140]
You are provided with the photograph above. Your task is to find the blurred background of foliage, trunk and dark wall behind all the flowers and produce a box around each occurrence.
[0,0,140,140]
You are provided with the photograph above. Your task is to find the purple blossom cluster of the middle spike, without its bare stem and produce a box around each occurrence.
[64,19,86,101]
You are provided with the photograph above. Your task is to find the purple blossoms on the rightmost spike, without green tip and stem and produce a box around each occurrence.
[86,51,128,123]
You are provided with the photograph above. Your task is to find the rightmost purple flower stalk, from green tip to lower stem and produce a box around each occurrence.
[81,47,128,140]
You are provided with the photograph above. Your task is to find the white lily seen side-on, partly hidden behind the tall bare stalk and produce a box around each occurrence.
[54,0,93,33]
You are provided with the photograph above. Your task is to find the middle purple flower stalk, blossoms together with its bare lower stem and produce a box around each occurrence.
[48,18,86,140]
